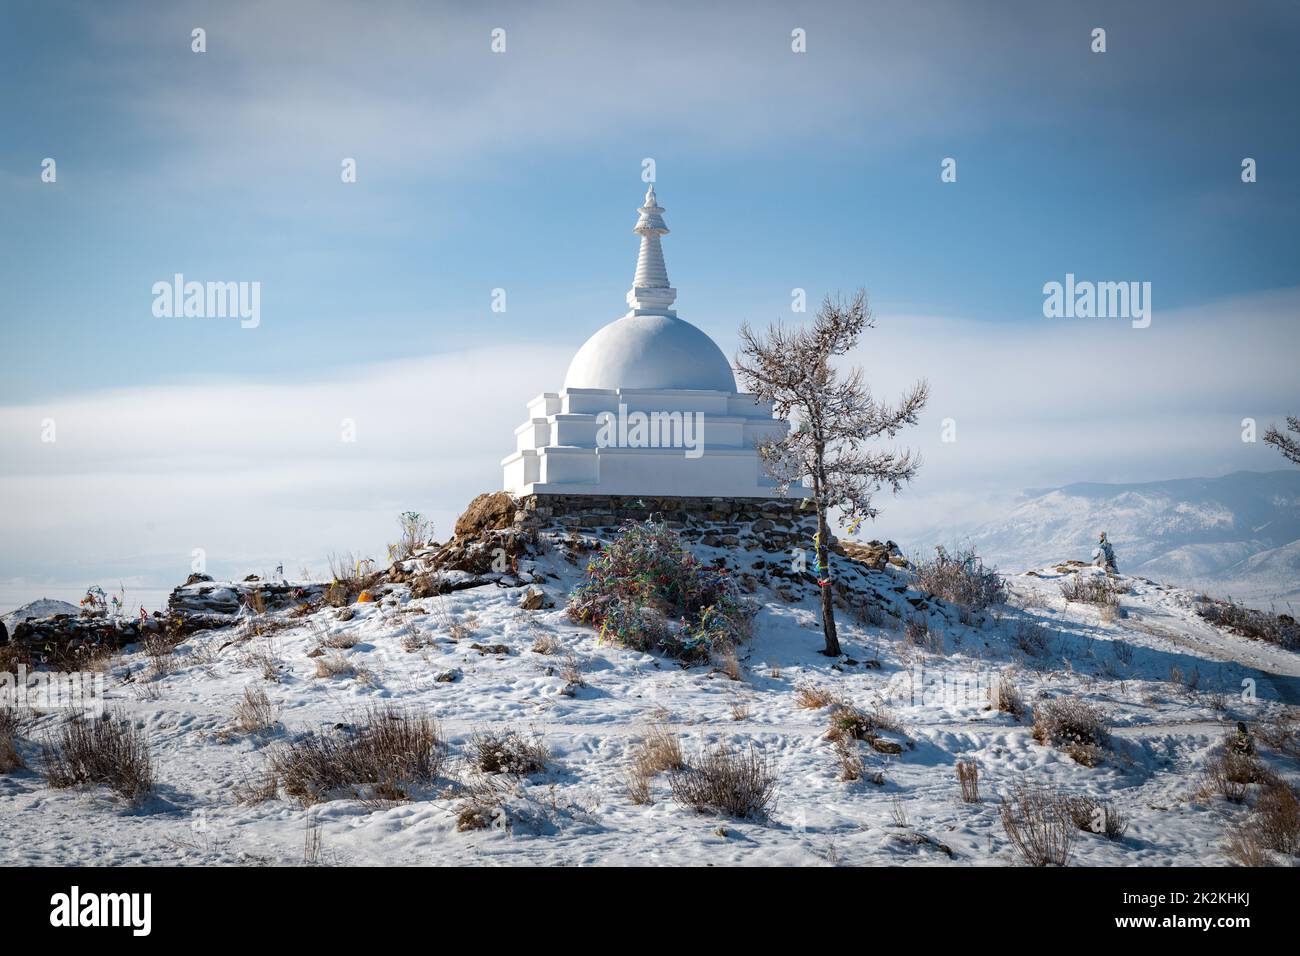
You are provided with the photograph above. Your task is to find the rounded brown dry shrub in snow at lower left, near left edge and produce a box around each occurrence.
[42,714,153,800]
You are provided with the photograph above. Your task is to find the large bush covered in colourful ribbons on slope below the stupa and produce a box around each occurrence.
[568,522,754,661]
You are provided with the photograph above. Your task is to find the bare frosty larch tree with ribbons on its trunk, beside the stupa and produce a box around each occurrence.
[736,289,930,657]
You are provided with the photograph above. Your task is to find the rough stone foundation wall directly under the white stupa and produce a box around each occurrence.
[515,494,816,553]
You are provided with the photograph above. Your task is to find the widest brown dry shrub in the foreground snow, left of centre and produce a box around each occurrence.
[270,706,447,806]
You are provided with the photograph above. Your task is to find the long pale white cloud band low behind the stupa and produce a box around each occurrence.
[0,290,1300,595]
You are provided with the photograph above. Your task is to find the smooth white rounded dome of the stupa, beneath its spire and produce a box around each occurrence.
[564,315,736,393]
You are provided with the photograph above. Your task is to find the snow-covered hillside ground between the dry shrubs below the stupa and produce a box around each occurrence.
[0,538,1300,865]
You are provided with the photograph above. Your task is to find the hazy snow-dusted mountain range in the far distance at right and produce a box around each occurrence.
[961,470,1300,610]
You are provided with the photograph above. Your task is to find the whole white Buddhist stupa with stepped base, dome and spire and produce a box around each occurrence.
[502,186,806,498]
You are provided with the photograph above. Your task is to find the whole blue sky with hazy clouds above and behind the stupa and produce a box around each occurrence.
[0,0,1300,598]
